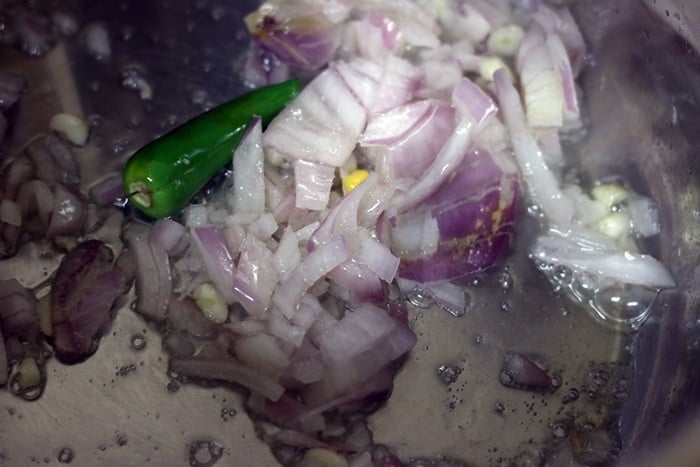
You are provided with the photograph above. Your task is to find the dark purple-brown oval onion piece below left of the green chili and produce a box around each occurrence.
[51,240,126,363]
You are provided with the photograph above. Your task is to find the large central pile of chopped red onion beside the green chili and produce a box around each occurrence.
[116,0,684,454]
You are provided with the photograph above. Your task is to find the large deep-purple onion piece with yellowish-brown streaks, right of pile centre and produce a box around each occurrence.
[394,151,520,282]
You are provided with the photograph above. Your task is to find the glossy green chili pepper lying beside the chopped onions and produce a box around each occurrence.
[123,79,300,218]
